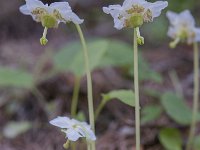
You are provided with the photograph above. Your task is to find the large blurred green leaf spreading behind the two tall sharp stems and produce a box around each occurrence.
[54,39,162,82]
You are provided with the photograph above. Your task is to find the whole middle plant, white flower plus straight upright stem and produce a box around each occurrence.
[103,0,168,150]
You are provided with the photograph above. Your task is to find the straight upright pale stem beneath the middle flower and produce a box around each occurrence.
[133,28,140,150]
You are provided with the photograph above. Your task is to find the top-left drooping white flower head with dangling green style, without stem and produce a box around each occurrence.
[19,0,83,45]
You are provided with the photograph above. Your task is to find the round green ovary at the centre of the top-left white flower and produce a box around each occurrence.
[41,15,58,28]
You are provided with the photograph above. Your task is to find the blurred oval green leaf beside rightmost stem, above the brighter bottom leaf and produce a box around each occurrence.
[161,92,199,125]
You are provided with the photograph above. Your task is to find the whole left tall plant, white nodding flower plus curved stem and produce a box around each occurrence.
[20,0,95,150]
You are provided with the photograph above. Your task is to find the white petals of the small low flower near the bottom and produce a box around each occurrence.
[50,117,96,141]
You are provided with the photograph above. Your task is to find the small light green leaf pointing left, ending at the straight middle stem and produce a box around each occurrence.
[102,90,135,107]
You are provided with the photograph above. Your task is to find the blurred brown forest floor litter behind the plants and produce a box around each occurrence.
[0,36,197,150]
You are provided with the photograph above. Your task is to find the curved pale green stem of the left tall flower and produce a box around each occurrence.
[75,24,95,150]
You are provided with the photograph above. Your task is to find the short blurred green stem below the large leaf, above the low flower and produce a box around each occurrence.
[71,77,80,117]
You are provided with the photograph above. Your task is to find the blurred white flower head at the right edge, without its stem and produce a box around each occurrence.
[167,10,200,48]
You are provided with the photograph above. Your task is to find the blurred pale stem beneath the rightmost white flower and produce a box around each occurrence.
[186,42,199,150]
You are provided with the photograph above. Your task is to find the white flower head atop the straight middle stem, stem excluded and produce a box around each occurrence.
[103,0,168,30]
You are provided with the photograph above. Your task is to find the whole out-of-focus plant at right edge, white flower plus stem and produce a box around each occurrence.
[167,10,200,150]
